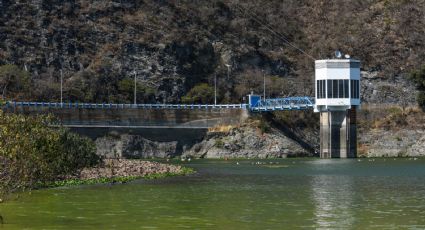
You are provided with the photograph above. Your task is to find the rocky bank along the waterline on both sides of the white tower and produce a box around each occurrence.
[88,105,425,159]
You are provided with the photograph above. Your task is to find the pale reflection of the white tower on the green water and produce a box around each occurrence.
[311,175,355,228]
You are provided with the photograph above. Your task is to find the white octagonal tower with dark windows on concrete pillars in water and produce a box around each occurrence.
[314,59,360,158]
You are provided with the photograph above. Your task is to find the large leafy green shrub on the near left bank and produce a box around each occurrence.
[0,111,99,194]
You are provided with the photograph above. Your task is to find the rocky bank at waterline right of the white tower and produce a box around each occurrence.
[358,105,425,157]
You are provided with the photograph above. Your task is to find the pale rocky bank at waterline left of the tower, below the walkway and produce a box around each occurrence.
[95,117,314,158]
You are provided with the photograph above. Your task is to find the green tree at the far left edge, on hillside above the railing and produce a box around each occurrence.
[0,64,30,100]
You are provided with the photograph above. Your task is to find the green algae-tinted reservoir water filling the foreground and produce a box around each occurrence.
[0,158,425,229]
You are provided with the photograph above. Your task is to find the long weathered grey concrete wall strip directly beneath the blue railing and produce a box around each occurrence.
[7,107,248,128]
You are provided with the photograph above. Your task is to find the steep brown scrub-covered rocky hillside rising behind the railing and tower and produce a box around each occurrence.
[0,0,425,103]
